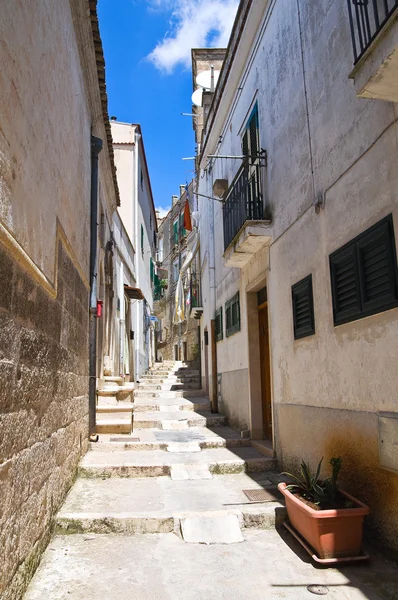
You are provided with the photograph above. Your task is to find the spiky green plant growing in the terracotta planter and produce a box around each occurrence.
[282,456,343,506]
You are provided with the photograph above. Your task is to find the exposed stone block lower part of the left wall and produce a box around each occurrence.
[0,241,88,600]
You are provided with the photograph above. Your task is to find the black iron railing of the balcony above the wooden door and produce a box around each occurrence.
[223,162,264,250]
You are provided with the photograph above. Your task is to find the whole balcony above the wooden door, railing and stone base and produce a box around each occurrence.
[223,161,271,268]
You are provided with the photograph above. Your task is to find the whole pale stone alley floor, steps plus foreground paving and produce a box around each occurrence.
[25,361,398,600]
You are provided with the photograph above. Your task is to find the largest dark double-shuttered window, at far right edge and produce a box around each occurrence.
[329,215,398,325]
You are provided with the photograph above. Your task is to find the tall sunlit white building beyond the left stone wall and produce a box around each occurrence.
[111,121,157,381]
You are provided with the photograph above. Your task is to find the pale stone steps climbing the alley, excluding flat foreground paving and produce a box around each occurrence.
[56,362,283,543]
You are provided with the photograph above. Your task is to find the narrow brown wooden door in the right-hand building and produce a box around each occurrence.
[258,303,272,440]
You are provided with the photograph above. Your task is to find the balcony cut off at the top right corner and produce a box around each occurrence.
[347,0,398,102]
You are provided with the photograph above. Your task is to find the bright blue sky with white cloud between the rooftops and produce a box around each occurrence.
[98,0,237,216]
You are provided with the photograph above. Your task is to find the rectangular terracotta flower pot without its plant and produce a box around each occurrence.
[278,483,370,558]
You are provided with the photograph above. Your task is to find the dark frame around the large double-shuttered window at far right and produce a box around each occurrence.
[329,214,398,326]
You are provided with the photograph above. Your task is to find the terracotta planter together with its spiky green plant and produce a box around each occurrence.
[278,457,370,562]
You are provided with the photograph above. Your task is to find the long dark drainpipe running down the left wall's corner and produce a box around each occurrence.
[88,135,102,441]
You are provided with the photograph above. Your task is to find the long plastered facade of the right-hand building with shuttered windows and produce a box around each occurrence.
[197,0,398,549]
